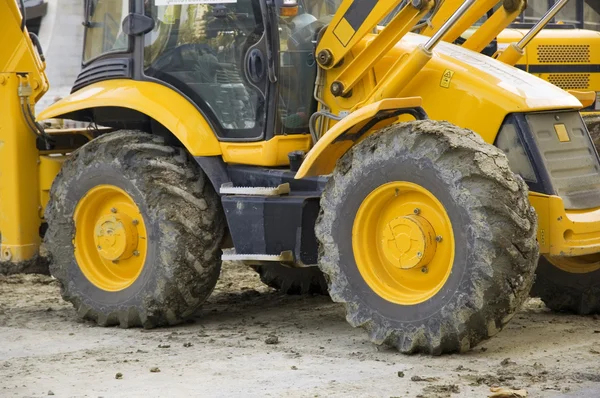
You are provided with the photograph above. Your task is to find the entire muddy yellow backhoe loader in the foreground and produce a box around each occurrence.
[0,0,600,354]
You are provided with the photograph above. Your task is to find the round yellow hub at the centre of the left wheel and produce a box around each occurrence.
[94,214,138,261]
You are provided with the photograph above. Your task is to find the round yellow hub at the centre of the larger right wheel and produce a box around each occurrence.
[381,215,436,269]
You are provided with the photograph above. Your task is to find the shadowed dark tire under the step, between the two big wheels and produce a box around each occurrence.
[252,264,328,295]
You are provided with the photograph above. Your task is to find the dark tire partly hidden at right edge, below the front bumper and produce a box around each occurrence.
[531,256,600,315]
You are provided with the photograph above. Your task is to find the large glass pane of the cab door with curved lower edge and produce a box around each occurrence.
[144,0,267,139]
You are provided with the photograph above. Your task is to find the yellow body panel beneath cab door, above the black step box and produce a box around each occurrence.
[220,134,311,167]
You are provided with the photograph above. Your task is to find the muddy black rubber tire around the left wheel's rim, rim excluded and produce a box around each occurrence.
[45,130,225,328]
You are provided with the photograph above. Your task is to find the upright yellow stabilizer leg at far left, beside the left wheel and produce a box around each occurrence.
[0,73,41,263]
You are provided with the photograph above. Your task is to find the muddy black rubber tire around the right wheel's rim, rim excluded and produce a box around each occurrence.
[316,120,539,355]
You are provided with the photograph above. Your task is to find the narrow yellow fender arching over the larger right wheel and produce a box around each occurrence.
[295,97,427,179]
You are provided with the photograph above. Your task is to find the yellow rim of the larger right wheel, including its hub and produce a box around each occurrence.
[352,182,454,305]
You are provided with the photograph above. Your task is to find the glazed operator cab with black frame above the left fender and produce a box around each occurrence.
[79,0,341,141]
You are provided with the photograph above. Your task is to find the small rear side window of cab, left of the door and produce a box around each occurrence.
[83,0,129,63]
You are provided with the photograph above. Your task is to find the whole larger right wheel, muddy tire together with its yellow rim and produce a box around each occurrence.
[316,120,538,355]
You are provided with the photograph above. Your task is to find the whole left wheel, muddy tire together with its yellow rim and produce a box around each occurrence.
[46,131,224,328]
